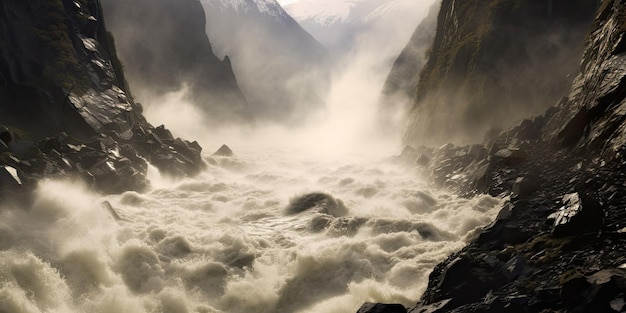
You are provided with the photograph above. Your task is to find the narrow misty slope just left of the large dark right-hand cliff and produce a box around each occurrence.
[380,1,441,125]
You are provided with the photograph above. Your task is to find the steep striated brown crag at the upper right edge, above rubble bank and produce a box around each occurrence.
[544,1,626,161]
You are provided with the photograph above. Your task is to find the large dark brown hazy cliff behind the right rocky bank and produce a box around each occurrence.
[405,0,598,144]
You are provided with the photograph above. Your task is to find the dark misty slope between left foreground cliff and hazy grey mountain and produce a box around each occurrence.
[97,0,252,123]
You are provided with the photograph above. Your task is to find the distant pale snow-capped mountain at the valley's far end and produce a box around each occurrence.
[285,0,433,59]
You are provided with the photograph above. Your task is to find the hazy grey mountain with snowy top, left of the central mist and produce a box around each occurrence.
[201,0,329,123]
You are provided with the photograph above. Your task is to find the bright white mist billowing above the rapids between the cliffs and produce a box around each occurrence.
[135,1,431,156]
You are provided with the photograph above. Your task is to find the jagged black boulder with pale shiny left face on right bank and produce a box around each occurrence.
[548,193,604,237]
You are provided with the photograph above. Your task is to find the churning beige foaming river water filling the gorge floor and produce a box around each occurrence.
[0,151,500,313]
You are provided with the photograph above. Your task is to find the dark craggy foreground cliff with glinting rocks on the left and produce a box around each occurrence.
[0,0,204,197]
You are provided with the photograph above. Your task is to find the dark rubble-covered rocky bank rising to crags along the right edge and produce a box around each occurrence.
[360,0,626,313]
